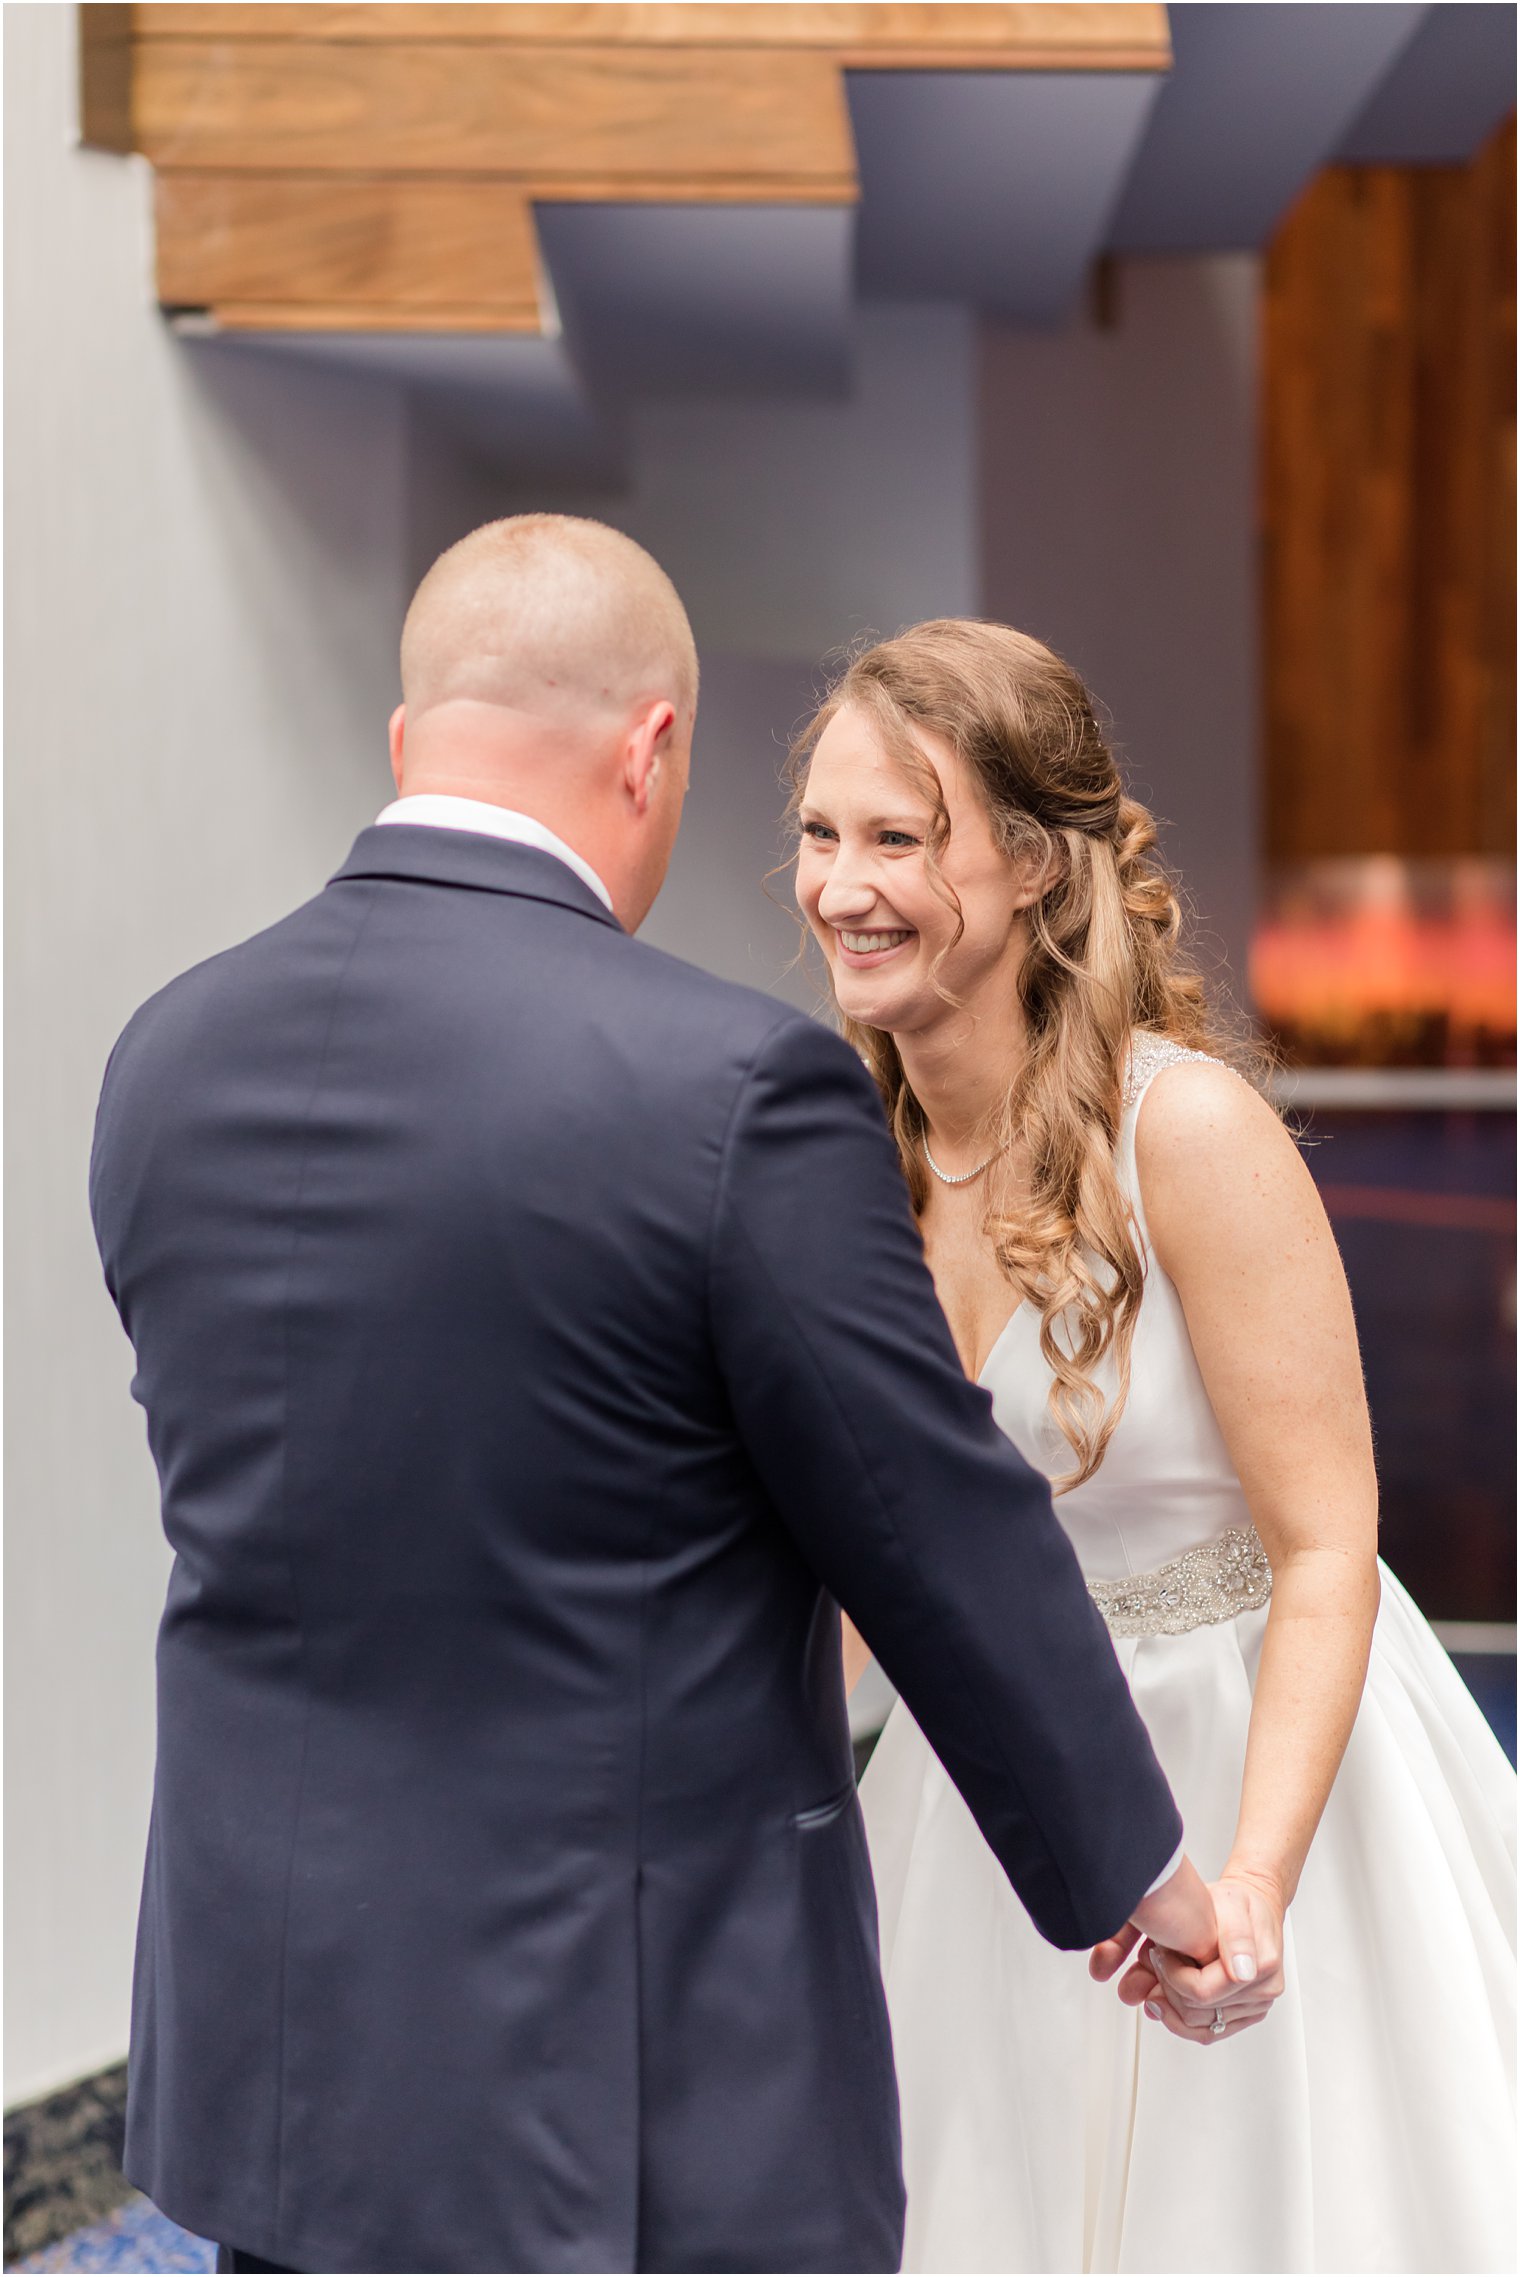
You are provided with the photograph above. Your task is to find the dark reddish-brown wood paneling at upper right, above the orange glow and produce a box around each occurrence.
[1263,118,1515,861]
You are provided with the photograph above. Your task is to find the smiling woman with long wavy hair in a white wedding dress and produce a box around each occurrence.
[794,619,1513,2272]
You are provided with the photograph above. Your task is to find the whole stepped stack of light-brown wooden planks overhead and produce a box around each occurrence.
[80,0,1170,330]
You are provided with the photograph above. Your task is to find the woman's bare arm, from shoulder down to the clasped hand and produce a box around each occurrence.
[1135,1061,1379,2040]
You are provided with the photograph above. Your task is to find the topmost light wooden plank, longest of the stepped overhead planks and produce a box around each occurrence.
[132,0,1172,71]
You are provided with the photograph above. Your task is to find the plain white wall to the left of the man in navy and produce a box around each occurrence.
[5,5,405,2104]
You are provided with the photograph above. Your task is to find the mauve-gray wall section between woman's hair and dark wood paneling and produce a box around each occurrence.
[981,255,1258,997]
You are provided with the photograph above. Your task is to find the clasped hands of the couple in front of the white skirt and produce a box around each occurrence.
[1088,1858,1283,2047]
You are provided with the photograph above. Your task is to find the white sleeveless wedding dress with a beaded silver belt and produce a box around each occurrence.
[860,1036,1515,2272]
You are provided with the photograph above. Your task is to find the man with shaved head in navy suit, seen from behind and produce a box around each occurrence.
[91,515,1213,2270]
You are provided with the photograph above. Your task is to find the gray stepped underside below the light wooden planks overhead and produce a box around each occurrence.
[199,0,1515,478]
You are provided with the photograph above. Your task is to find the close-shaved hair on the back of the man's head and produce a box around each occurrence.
[400,515,696,724]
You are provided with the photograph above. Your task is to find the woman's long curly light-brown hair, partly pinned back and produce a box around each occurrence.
[787,617,1247,1491]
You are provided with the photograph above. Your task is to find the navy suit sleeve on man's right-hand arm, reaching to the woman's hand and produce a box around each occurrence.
[710,1020,1181,1947]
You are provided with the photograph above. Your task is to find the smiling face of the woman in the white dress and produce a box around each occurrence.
[796,708,1033,1036]
